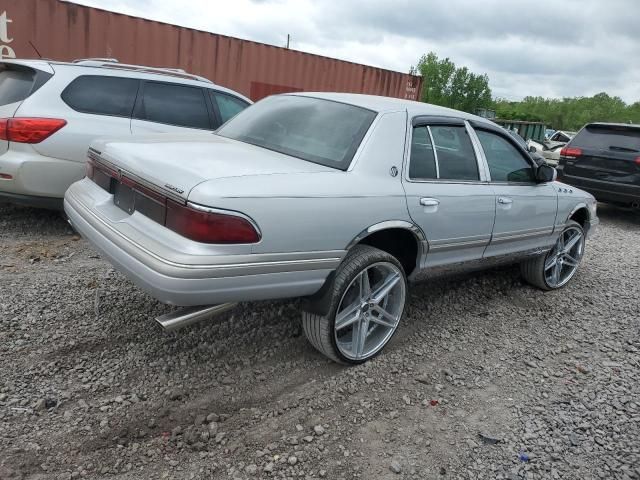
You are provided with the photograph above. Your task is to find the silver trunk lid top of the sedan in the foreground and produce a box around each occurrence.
[91,133,334,200]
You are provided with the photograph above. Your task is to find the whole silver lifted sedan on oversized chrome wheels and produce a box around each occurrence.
[65,93,598,363]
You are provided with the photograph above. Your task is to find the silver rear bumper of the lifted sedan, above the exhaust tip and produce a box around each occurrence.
[64,180,345,306]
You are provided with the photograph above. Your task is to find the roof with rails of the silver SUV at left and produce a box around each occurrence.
[0,59,253,103]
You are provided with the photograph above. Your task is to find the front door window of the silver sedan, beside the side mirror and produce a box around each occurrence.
[476,130,535,182]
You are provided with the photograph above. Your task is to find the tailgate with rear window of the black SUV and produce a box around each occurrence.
[563,124,640,185]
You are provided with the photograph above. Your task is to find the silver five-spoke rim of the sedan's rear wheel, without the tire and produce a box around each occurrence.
[334,262,406,360]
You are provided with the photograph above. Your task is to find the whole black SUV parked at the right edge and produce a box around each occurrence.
[557,123,640,208]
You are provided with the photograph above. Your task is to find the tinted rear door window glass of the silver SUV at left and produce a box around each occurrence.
[136,82,211,129]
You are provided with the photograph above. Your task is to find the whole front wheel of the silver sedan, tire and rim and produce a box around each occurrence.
[520,220,585,290]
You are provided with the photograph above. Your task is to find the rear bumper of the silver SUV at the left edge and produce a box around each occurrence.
[0,146,84,203]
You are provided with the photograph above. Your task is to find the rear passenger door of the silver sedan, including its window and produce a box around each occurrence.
[403,117,495,268]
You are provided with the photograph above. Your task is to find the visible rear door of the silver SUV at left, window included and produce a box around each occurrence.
[131,80,216,135]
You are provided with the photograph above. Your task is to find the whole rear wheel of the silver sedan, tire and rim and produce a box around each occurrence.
[302,245,408,365]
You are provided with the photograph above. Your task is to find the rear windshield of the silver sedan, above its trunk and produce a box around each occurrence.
[217,95,376,170]
